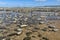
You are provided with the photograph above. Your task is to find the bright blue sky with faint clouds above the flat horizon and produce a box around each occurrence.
[0,0,60,7]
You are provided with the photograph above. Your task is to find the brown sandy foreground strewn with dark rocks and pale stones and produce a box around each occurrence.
[0,20,60,40]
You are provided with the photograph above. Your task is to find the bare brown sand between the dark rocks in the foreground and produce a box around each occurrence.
[7,20,60,40]
